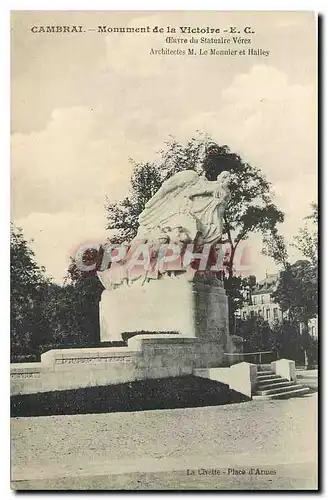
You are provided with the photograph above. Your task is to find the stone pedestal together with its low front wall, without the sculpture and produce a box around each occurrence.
[11,275,242,394]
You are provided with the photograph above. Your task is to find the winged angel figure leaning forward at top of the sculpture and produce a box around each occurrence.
[134,170,230,245]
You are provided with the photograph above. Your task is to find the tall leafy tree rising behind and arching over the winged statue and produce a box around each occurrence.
[106,134,284,328]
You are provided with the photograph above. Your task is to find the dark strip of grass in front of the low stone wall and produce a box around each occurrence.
[11,375,249,417]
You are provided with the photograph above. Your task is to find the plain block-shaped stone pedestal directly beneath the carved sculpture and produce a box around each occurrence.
[99,275,228,345]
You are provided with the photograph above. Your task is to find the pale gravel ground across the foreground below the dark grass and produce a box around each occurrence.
[11,394,317,488]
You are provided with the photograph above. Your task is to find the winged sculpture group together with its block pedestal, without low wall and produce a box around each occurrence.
[98,170,236,351]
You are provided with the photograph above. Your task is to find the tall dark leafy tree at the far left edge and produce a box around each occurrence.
[10,224,49,360]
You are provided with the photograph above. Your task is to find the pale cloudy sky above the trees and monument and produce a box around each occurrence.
[11,11,317,283]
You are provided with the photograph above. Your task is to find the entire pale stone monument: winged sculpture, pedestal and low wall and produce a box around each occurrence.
[11,170,243,394]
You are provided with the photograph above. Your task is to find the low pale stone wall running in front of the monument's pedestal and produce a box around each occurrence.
[11,335,229,394]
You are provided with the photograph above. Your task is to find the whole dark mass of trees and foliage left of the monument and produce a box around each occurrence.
[11,226,103,361]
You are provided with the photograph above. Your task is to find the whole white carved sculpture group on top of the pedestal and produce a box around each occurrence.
[97,170,230,290]
